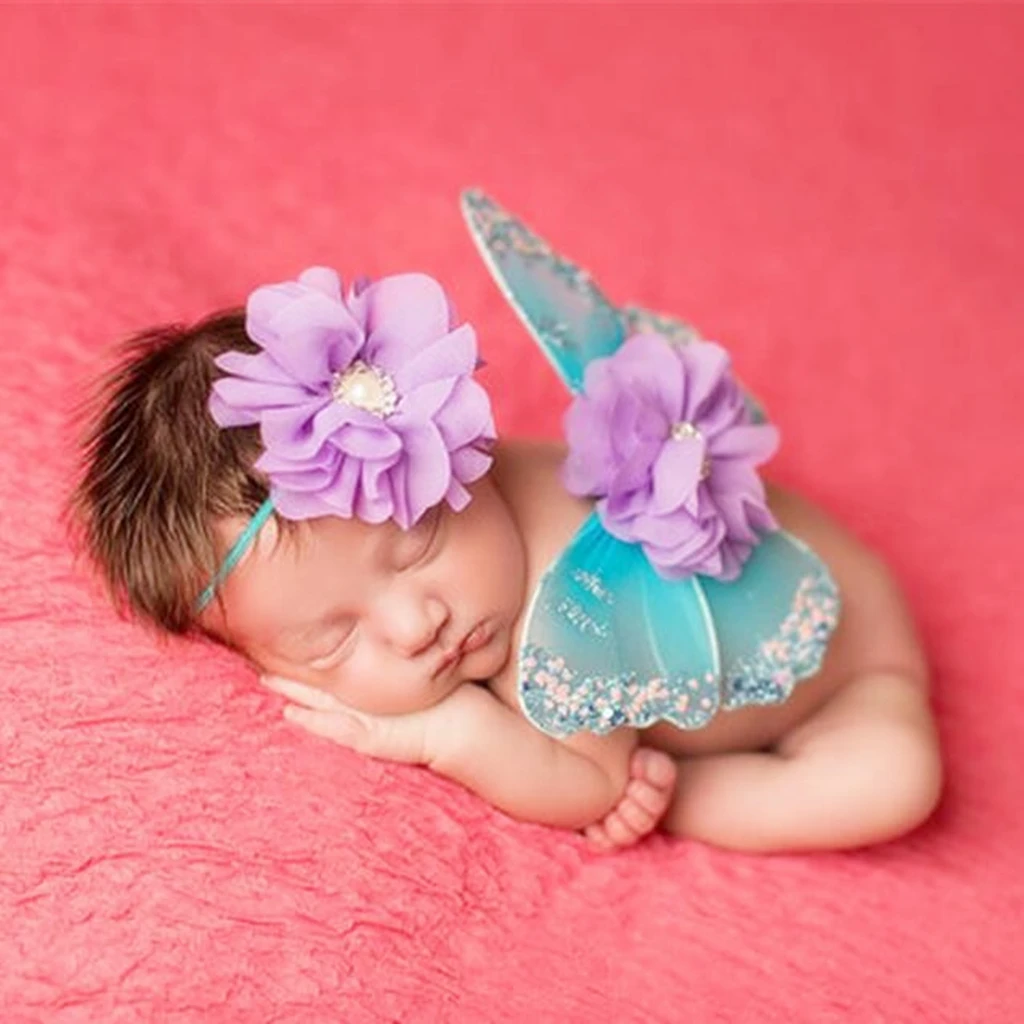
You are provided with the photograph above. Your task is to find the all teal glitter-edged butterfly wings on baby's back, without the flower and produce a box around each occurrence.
[463,190,840,736]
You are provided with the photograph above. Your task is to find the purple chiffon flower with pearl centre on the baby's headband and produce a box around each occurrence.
[210,267,496,528]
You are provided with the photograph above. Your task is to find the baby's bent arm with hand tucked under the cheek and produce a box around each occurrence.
[264,679,637,828]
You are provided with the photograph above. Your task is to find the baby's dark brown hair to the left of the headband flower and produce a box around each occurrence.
[70,309,268,634]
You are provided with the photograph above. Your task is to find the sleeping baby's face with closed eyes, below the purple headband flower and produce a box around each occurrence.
[208,478,525,715]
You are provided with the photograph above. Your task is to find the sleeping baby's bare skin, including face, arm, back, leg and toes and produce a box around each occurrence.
[203,442,941,852]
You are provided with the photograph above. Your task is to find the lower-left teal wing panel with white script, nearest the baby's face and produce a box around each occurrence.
[519,514,721,736]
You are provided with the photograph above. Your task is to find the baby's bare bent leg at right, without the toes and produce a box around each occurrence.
[663,669,941,852]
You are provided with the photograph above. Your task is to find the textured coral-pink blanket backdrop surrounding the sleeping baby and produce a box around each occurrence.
[0,5,1024,1024]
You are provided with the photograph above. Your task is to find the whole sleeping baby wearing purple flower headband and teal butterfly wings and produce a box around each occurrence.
[74,191,941,852]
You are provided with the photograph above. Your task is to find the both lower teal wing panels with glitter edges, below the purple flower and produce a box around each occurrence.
[519,514,839,736]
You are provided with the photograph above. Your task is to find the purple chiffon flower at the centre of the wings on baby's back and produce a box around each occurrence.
[563,334,778,580]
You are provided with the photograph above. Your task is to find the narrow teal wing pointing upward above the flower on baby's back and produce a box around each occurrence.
[462,189,626,392]
